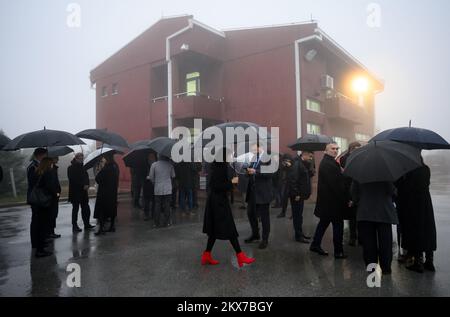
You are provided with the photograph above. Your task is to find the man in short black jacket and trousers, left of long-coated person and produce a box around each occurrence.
[67,153,95,233]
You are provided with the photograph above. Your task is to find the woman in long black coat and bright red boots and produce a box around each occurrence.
[201,149,255,267]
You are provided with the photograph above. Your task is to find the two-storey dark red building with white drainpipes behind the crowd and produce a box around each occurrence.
[91,16,383,185]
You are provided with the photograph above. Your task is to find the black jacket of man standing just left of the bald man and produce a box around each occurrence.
[287,158,311,200]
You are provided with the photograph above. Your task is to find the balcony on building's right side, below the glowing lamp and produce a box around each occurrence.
[325,93,369,124]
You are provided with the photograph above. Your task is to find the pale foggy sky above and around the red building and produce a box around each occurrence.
[0,0,450,140]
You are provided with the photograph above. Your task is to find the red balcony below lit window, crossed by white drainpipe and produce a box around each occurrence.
[150,92,224,127]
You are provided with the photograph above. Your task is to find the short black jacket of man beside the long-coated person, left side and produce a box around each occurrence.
[67,160,89,204]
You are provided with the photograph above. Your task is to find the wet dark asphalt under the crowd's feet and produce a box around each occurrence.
[0,173,450,297]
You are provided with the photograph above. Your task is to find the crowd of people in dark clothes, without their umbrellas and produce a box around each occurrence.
[27,142,437,274]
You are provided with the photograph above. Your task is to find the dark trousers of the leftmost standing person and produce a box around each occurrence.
[30,206,50,251]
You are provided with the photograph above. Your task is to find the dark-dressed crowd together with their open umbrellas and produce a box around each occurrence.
[2,123,450,274]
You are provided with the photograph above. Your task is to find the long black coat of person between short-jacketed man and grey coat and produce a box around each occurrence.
[94,163,119,220]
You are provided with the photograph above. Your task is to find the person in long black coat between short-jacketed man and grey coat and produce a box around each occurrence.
[94,152,119,235]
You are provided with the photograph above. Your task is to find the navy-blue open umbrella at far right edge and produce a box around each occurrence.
[370,127,450,150]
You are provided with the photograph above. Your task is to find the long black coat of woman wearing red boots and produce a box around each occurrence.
[203,162,239,240]
